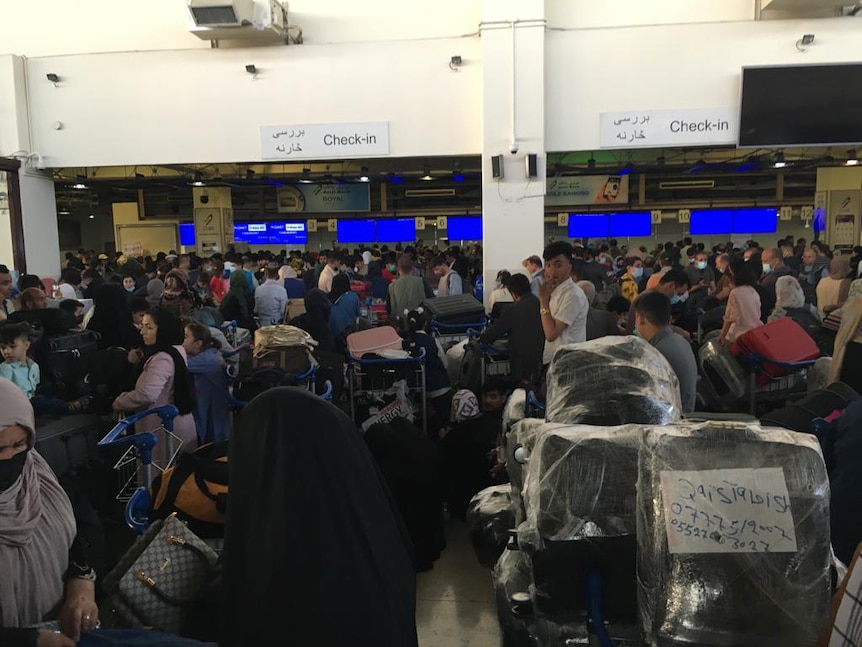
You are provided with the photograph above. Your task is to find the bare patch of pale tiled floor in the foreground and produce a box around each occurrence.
[416,521,500,647]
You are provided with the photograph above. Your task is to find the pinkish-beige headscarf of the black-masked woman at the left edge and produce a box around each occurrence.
[0,378,76,627]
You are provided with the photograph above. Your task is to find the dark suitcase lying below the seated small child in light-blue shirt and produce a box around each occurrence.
[35,415,107,477]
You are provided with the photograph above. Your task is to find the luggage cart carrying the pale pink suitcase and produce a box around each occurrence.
[347,348,428,434]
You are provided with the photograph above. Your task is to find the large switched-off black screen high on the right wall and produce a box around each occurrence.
[739,63,862,148]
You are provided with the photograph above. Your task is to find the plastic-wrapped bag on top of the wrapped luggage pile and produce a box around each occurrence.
[545,335,682,426]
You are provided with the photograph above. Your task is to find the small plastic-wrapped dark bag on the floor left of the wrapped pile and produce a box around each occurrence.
[467,483,515,568]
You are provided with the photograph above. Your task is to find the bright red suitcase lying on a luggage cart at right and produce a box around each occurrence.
[736,317,820,379]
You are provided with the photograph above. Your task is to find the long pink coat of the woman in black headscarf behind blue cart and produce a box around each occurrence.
[114,346,198,463]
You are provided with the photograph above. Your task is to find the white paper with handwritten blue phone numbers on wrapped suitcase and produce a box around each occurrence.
[661,467,796,554]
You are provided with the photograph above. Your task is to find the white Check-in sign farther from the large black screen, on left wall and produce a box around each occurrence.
[260,121,389,160]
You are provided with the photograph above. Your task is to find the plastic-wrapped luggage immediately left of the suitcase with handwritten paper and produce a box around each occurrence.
[518,425,641,625]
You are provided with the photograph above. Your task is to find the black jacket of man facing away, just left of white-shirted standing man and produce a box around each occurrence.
[479,294,545,382]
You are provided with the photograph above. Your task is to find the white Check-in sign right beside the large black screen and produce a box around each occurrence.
[600,108,739,148]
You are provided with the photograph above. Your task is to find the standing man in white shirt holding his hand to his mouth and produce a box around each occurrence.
[539,241,590,365]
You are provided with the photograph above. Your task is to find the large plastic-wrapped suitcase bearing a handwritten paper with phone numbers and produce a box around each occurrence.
[638,423,831,647]
